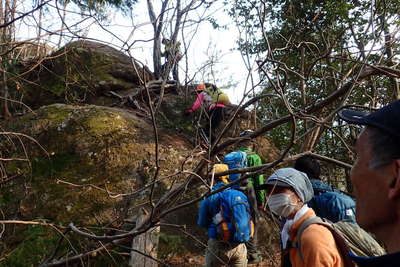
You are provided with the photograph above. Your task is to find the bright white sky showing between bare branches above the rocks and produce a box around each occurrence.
[17,0,258,103]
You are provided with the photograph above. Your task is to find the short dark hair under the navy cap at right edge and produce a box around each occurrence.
[367,126,400,169]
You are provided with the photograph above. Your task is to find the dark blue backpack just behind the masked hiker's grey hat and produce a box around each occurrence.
[307,180,356,223]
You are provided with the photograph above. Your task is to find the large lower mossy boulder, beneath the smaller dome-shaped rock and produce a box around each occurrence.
[0,104,197,265]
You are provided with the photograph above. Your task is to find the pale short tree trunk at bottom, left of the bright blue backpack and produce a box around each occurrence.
[129,209,160,267]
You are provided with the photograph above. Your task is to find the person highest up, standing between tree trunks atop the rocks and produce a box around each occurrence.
[161,38,183,83]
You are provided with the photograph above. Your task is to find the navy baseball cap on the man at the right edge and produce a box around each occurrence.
[338,100,400,137]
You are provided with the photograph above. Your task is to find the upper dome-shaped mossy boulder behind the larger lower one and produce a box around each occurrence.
[11,41,153,108]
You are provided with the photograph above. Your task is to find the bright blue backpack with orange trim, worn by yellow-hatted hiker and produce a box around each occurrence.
[213,189,254,243]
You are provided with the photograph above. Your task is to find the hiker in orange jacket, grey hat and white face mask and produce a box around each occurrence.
[260,168,352,267]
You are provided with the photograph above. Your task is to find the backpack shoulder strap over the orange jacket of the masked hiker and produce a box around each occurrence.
[293,216,355,267]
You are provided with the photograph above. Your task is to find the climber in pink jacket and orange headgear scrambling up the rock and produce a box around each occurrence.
[185,84,230,144]
